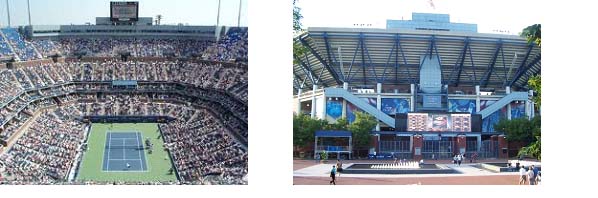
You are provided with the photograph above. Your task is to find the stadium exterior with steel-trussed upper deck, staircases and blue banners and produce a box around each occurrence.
[293,13,541,160]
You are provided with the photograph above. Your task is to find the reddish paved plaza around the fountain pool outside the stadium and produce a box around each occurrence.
[293,159,539,185]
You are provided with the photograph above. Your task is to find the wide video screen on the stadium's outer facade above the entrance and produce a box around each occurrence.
[407,113,471,132]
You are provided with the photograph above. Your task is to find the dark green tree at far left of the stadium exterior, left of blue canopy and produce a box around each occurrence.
[293,115,327,146]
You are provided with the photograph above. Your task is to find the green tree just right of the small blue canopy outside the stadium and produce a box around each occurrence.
[348,112,378,147]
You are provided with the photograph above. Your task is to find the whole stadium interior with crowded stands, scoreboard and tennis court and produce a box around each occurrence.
[0,2,248,184]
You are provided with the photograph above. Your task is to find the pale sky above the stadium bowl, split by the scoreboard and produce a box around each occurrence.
[0,0,248,26]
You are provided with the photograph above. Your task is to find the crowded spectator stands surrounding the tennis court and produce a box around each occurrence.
[0,28,248,184]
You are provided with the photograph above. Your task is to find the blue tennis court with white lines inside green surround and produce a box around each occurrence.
[102,132,147,172]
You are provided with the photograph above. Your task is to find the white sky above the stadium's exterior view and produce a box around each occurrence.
[297,0,545,34]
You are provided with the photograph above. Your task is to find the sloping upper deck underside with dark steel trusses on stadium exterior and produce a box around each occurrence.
[293,14,541,91]
